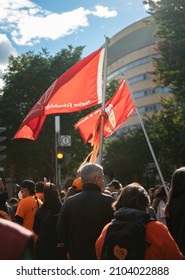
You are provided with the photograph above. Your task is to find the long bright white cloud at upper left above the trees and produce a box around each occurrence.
[11,8,89,45]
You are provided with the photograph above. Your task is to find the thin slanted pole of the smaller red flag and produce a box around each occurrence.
[123,75,168,195]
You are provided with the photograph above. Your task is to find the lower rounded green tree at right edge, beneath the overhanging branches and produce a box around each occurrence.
[149,98,185,178]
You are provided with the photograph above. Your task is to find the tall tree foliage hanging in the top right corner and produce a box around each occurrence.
[144,0,185,103]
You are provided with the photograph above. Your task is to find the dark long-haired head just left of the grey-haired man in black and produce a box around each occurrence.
[43,182,61,208]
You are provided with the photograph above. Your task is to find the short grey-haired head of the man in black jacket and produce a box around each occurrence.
[80,163,104,190]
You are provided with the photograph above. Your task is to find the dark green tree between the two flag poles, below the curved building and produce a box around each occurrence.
[103,130,155,187]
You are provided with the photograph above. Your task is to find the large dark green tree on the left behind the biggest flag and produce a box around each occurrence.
[0,46,92,180]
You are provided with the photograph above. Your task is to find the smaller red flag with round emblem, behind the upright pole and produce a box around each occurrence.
[75,80,136,143]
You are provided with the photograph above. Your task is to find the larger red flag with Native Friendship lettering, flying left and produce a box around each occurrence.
[13,48,104,140]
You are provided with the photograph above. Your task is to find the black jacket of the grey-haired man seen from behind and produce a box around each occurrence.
[57,184,114,260]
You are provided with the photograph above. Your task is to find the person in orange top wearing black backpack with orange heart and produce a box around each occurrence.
[96,184,184,260]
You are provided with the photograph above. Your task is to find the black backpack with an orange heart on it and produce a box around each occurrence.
[101,213,151,260]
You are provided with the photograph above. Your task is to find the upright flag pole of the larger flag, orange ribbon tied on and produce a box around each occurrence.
[98,37,109,165]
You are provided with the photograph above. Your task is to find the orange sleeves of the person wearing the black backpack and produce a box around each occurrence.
[96,221,183,260]
